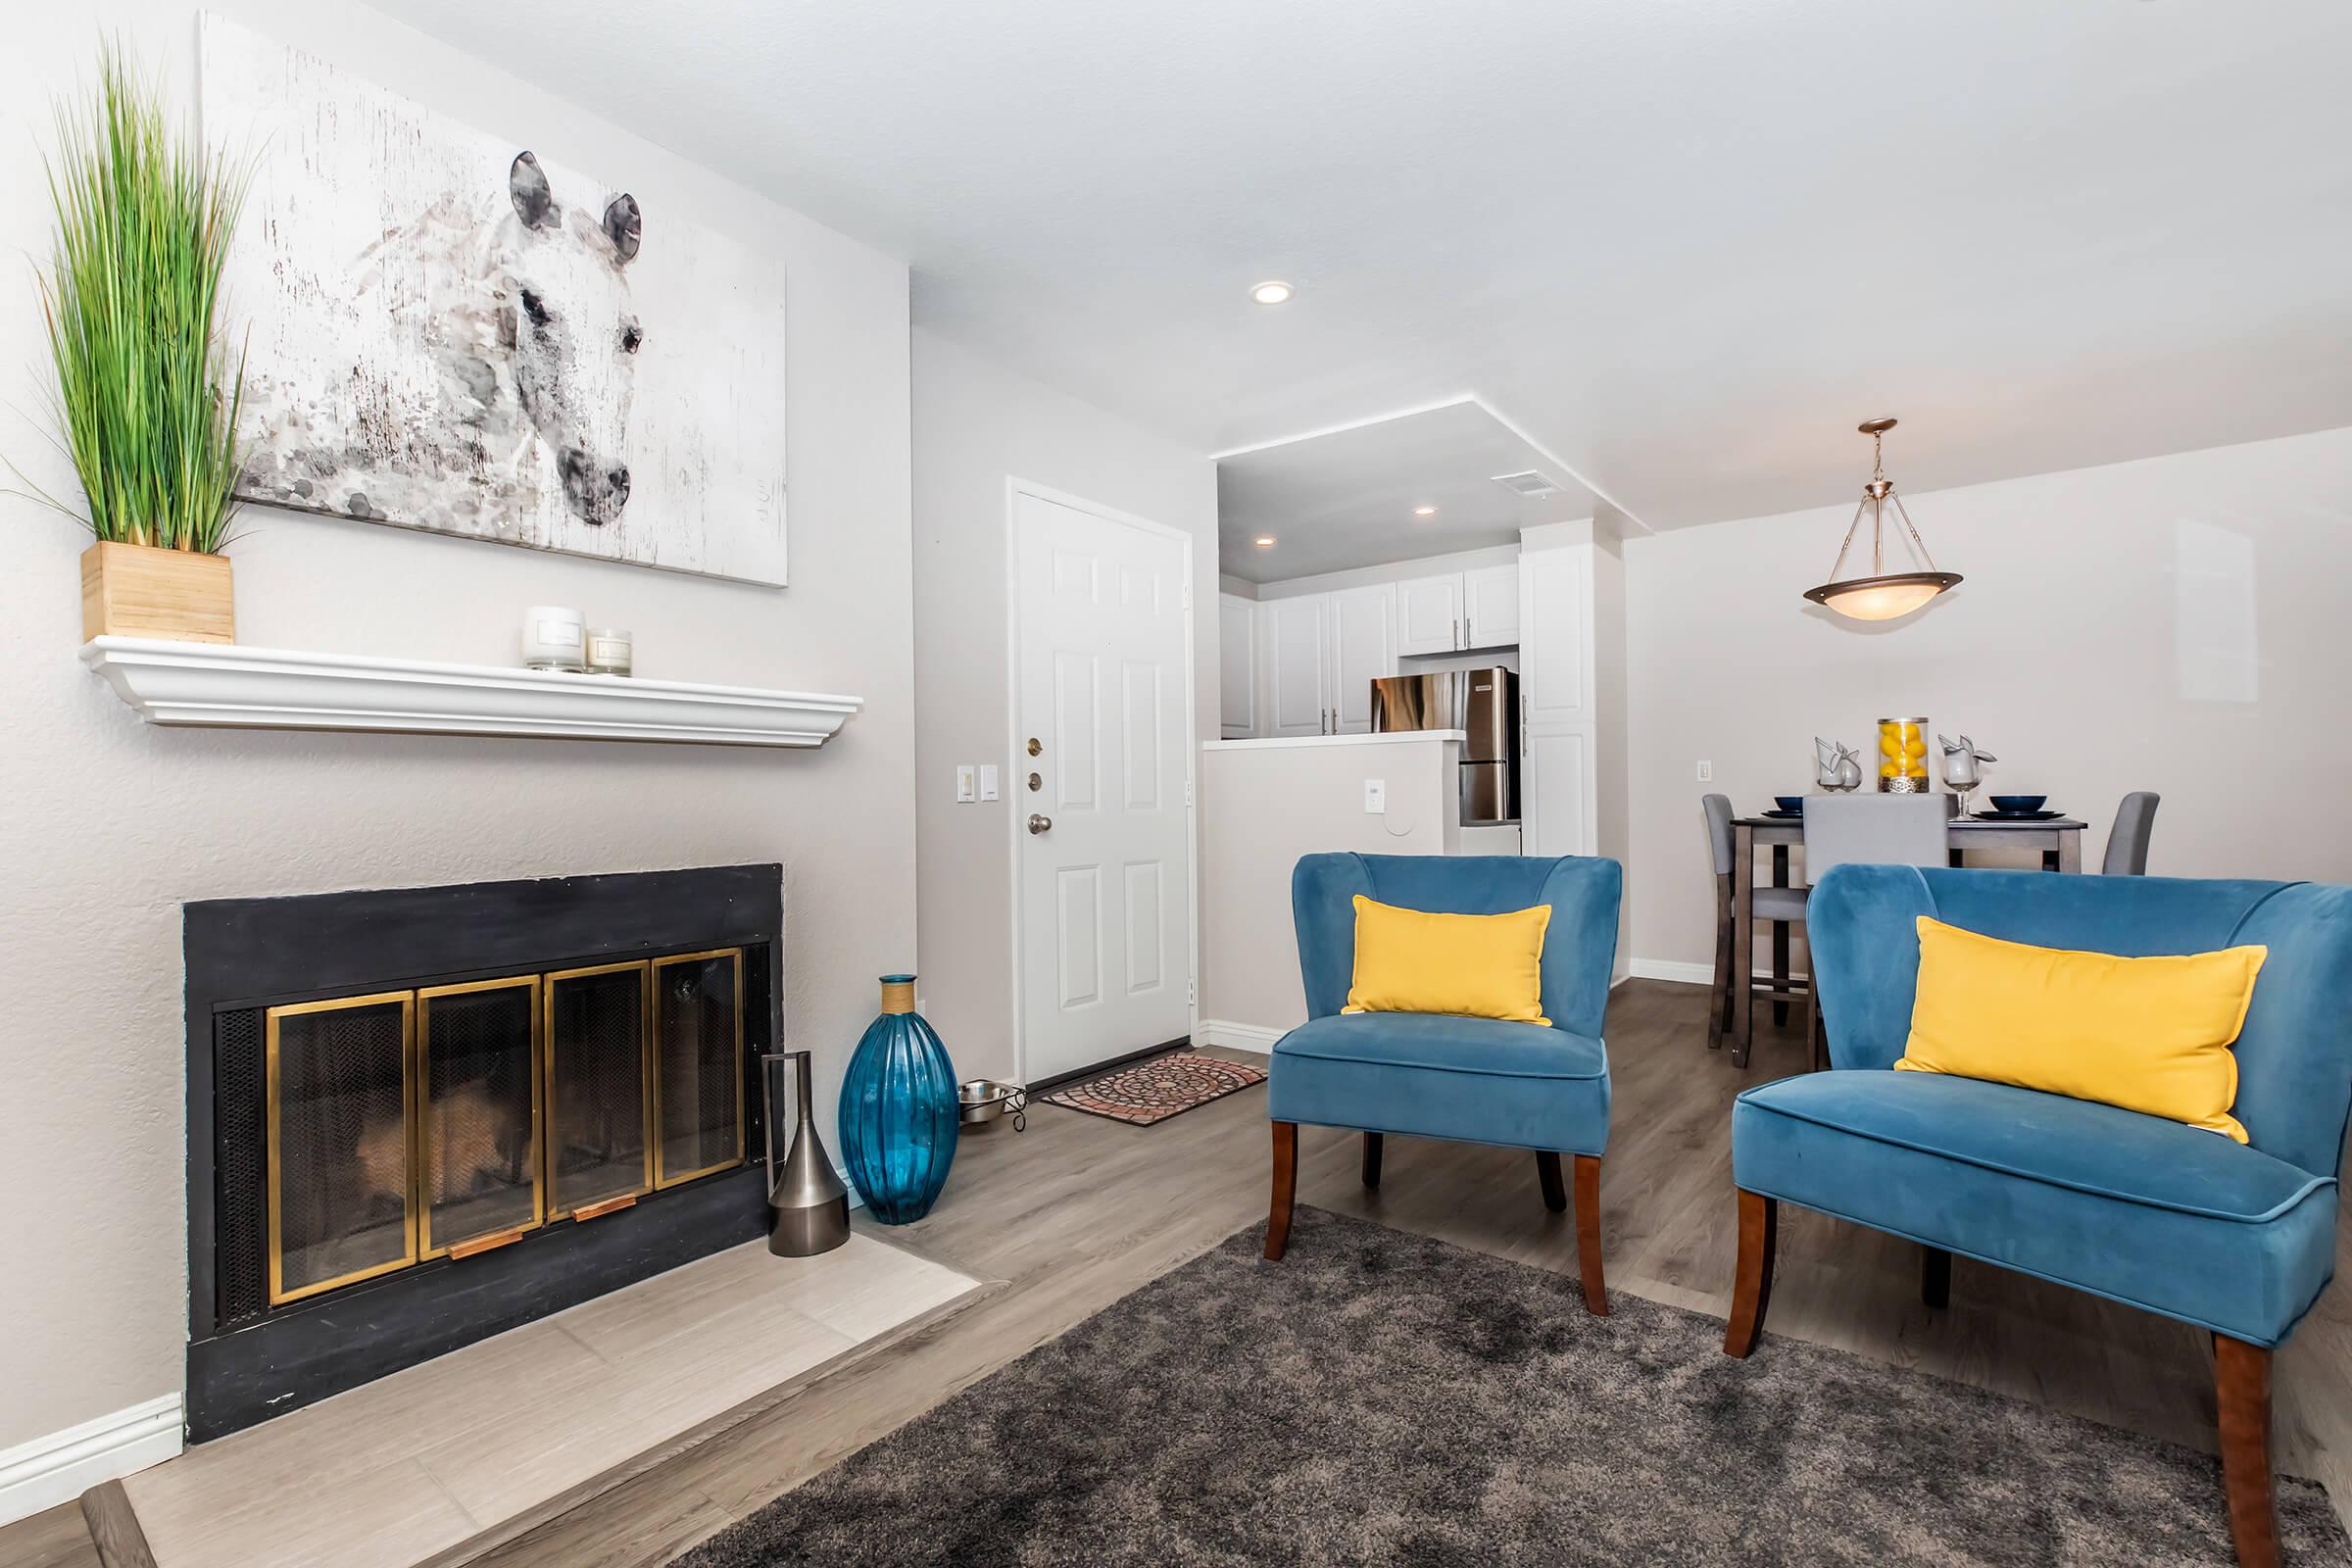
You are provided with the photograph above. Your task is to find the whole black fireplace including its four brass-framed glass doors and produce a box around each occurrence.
[186,865,781,1441]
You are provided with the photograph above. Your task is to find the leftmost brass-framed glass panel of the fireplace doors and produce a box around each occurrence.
[266,992,416,1304]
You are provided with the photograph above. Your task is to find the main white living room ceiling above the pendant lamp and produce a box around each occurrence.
[378,0,2352,526]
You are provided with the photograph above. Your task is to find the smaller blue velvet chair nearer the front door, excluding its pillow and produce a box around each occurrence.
[1265,856,1623,1314]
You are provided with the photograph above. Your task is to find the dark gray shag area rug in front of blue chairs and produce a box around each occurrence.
[677,1208,2352,1568]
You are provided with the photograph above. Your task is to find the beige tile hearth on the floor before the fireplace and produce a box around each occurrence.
[124,1234,978,1568]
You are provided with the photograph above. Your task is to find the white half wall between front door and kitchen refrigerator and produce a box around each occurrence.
[1200,731,1460,1051]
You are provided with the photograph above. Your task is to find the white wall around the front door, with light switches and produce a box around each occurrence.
[915,331,1218,1077]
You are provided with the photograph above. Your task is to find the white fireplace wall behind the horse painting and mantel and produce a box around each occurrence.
[0,0,915,1476]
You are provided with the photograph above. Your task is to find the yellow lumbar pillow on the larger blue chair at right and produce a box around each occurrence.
[1895,914,2270,1143]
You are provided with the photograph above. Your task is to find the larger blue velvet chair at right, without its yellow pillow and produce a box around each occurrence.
[1724,865,2352,1566]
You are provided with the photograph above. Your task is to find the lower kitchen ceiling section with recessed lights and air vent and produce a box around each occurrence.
[1216,400,1597,583]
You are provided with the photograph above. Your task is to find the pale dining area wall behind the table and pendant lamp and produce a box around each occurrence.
[1625,430,2352,966]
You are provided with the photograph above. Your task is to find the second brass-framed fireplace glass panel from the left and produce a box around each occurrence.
[416,976,543,1257]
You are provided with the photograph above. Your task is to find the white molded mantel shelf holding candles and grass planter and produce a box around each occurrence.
[82,637,865,748]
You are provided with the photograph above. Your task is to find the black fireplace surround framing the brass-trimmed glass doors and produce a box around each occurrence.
[183,865,783,1441]
